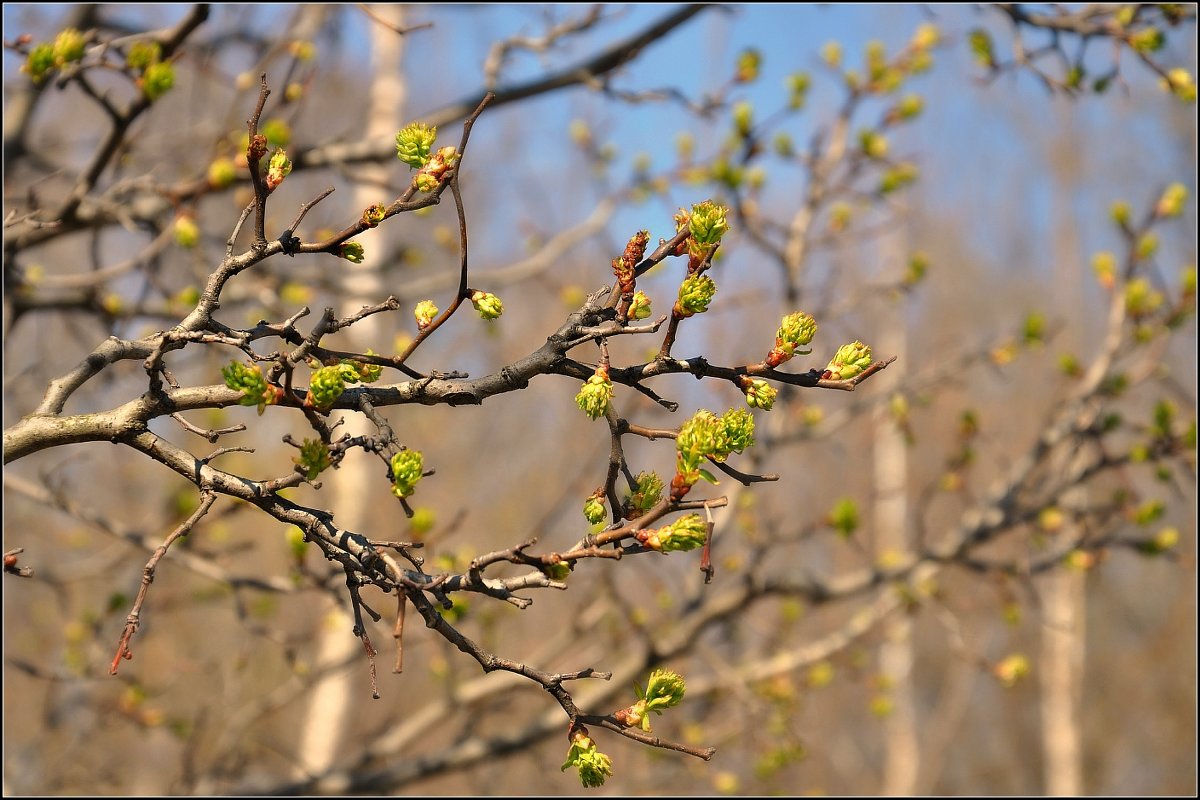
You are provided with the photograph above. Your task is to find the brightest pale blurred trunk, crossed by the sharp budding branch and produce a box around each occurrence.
[298,6,407,775]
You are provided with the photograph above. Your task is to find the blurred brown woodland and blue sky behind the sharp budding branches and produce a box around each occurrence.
[4,4,1196,795]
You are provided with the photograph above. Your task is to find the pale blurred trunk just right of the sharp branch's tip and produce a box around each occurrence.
[874,223,920,795]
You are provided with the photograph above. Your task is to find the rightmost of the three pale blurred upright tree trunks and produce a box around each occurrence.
[1038,107,1087,796]
